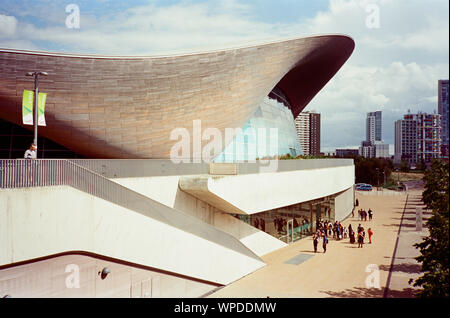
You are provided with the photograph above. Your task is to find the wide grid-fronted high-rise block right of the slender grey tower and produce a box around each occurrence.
[394,112,441,165]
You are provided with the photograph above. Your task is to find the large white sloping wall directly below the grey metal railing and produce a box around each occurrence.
[0,186,265,285]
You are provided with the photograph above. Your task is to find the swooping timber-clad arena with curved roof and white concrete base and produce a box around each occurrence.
[0,35,355,297]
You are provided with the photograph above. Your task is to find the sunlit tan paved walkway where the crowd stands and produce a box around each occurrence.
[208,189,424,298]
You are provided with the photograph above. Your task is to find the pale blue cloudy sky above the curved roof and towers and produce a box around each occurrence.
[0,0,449,153]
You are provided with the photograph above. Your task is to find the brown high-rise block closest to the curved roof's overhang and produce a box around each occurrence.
[295,111,320,156]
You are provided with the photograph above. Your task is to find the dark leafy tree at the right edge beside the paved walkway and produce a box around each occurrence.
[410,160,450,297]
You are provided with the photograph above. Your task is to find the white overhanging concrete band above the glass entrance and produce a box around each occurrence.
[180,165,355,214]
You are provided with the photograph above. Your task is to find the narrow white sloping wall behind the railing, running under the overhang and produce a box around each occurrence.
[114,176,286,256]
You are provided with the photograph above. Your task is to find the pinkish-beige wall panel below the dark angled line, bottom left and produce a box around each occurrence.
[0,254,217,298]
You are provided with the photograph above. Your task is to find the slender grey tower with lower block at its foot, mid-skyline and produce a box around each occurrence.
[359,110,389,158]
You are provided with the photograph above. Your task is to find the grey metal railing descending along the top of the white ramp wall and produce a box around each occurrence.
[0,159,259,260]
